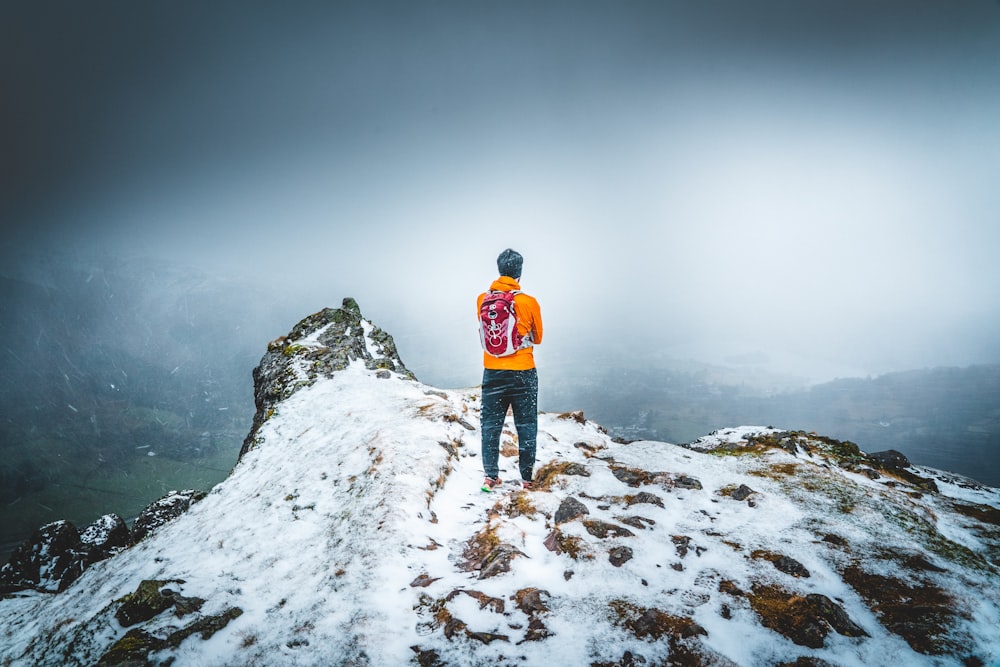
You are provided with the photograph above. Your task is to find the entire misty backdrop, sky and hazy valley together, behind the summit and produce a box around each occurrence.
[0,0,1000,546]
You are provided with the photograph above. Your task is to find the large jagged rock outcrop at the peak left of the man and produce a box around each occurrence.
[240,297,416,458]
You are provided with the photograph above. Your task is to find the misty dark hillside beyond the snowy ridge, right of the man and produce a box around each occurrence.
[550,365,1000,486]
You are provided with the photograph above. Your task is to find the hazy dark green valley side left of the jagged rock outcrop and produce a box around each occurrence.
[0,260,260,560]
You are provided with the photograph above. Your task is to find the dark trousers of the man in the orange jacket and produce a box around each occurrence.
[481,368,538,481]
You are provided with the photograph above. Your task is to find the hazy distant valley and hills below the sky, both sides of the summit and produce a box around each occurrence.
[0,260,1000,556]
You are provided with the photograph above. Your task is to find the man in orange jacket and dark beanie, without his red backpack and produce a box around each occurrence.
[476,248,542,492]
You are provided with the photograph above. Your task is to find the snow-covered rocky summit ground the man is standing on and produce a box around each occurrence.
[0,304,1000,666]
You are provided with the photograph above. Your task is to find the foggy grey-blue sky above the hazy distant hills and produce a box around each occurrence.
[0,0,1000,384]
